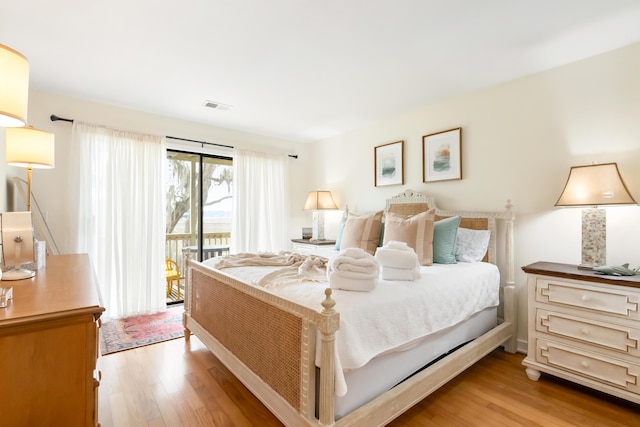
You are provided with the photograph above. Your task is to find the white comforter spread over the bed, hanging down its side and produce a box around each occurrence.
[205,261,500,395]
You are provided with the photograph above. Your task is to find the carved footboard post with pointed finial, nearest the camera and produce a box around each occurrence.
[318,288,340,426]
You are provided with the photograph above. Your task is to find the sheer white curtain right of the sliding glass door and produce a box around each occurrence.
[230,149,289,253]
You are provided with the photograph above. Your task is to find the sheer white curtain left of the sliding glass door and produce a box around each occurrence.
[71,122,166,317]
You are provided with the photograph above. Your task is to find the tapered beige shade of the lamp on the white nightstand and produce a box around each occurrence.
[556,163,636,206]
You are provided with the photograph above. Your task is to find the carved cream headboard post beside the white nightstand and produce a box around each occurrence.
[503,200,518,353]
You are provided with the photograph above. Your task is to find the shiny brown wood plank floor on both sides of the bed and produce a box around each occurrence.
[99,337,640,427]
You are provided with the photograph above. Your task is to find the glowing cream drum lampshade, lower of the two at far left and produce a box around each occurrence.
[6,126,55,168]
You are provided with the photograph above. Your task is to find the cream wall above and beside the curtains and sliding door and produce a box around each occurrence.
[0,88,313,253]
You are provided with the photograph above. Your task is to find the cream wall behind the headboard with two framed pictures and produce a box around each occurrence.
[314,44,640,348]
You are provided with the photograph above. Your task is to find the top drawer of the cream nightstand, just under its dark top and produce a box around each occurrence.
[536,278,640,320]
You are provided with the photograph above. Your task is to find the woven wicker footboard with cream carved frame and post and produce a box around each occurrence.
[184,260,339,425]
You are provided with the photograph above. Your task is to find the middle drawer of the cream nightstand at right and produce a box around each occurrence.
[536,309,640,357]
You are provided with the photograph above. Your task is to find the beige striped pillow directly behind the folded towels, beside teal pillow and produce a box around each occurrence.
[384,209,435,265]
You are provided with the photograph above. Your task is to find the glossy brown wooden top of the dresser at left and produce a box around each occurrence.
[0,254,104,327]
